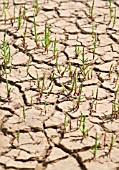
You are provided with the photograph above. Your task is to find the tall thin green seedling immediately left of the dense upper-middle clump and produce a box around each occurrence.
[33,15,40,48]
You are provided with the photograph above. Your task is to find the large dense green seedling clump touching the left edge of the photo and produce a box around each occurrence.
[1,32,11,73]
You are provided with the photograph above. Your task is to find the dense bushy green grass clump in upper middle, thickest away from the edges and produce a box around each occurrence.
[42,22,51,53]
